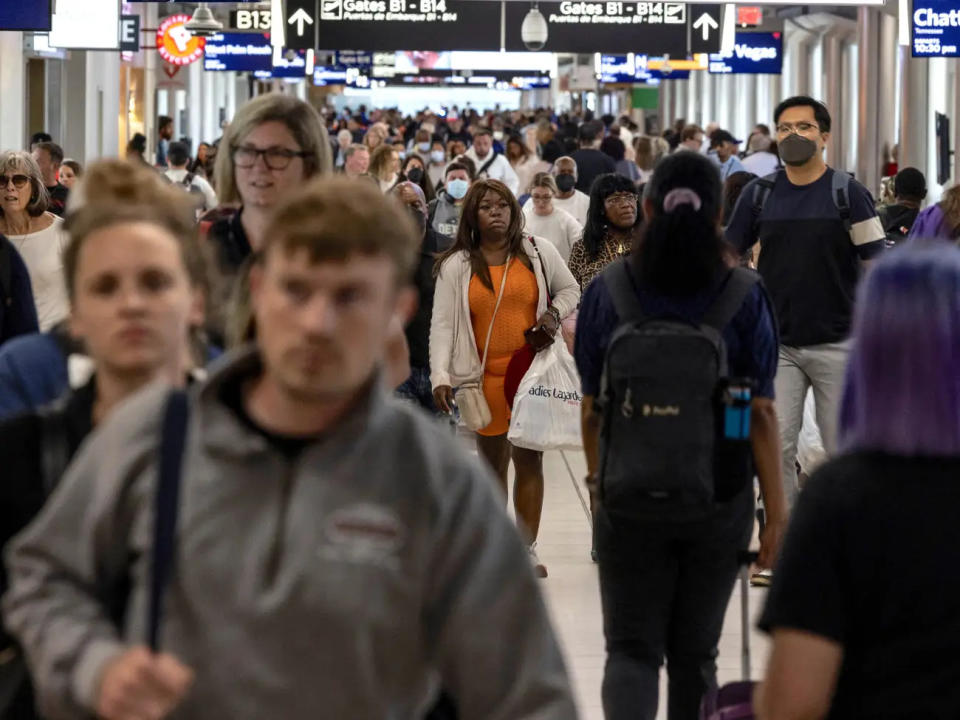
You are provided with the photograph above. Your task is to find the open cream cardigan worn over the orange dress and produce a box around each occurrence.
[430,237,580,389]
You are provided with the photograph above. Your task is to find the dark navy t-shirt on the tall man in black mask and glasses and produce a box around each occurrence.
[726,168,884,347]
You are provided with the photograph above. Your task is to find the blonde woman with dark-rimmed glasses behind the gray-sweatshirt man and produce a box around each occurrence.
[201,93,332,346]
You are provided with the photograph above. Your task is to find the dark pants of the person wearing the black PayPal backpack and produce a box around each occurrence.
[595,486,753,720]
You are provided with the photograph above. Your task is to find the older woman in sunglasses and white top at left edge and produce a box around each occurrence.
[0,151,69,330]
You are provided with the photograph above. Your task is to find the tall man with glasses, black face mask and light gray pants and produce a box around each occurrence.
[726,97,884,524]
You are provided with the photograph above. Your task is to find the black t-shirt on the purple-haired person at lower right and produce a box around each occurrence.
[760,453,960,720]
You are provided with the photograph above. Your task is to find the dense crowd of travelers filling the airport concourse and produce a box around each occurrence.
[0,93,960,720]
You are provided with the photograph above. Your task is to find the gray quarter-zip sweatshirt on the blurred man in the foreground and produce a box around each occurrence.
[4,350,576,720]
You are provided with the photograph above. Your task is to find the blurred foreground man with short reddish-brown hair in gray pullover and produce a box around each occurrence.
[3,180,576,720]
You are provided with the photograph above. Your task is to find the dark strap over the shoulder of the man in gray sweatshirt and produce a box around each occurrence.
[147,390,190,652]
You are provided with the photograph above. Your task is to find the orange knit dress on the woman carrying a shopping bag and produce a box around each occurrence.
[469,259,540,437]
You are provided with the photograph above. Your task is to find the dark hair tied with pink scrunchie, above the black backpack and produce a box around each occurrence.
[634,152,724,296]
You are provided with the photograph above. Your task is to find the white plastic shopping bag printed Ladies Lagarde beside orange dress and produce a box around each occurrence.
[507,339,583,450]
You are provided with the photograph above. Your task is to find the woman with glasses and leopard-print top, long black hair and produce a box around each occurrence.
[569,173,642,291]
